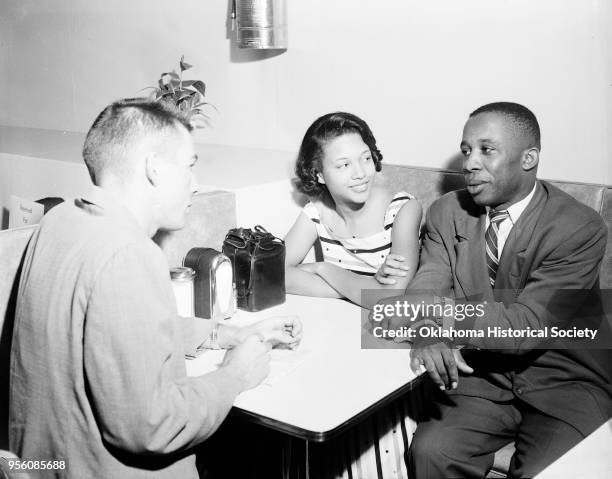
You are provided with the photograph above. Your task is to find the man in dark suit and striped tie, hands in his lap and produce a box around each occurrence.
[390,103,612,478]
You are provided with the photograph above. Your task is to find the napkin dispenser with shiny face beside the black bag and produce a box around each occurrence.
[183,248,236,320]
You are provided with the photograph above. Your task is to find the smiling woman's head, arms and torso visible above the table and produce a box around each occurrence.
[285,112,422,307]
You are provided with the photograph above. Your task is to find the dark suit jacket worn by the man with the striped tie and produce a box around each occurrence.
[407,182,612,434]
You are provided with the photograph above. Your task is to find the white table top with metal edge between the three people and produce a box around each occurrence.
[187,295,416,441]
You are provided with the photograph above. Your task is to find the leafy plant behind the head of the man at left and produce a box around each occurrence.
[149,55,214,128]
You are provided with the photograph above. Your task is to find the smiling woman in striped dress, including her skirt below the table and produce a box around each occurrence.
[285,112,422,479]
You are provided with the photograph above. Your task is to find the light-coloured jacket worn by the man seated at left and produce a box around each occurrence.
[9,188,239,479]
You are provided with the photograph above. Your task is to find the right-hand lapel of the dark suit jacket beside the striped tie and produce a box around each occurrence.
[495,182,547,289]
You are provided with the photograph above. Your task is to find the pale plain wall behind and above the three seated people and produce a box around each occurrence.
[0,0,612,184]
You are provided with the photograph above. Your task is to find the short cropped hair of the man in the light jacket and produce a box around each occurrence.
[83,98,192,185]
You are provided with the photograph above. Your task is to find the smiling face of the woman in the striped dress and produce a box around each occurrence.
[317,133,376,204]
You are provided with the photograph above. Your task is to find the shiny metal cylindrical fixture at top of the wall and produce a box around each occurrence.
[232,0,287,50]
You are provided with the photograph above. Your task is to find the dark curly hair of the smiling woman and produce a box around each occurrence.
[295,111,382,197]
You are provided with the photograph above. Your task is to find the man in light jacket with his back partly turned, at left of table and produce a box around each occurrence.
[9,99,301,479]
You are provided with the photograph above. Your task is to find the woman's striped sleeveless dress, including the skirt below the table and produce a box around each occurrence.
[303,191,416,479]
